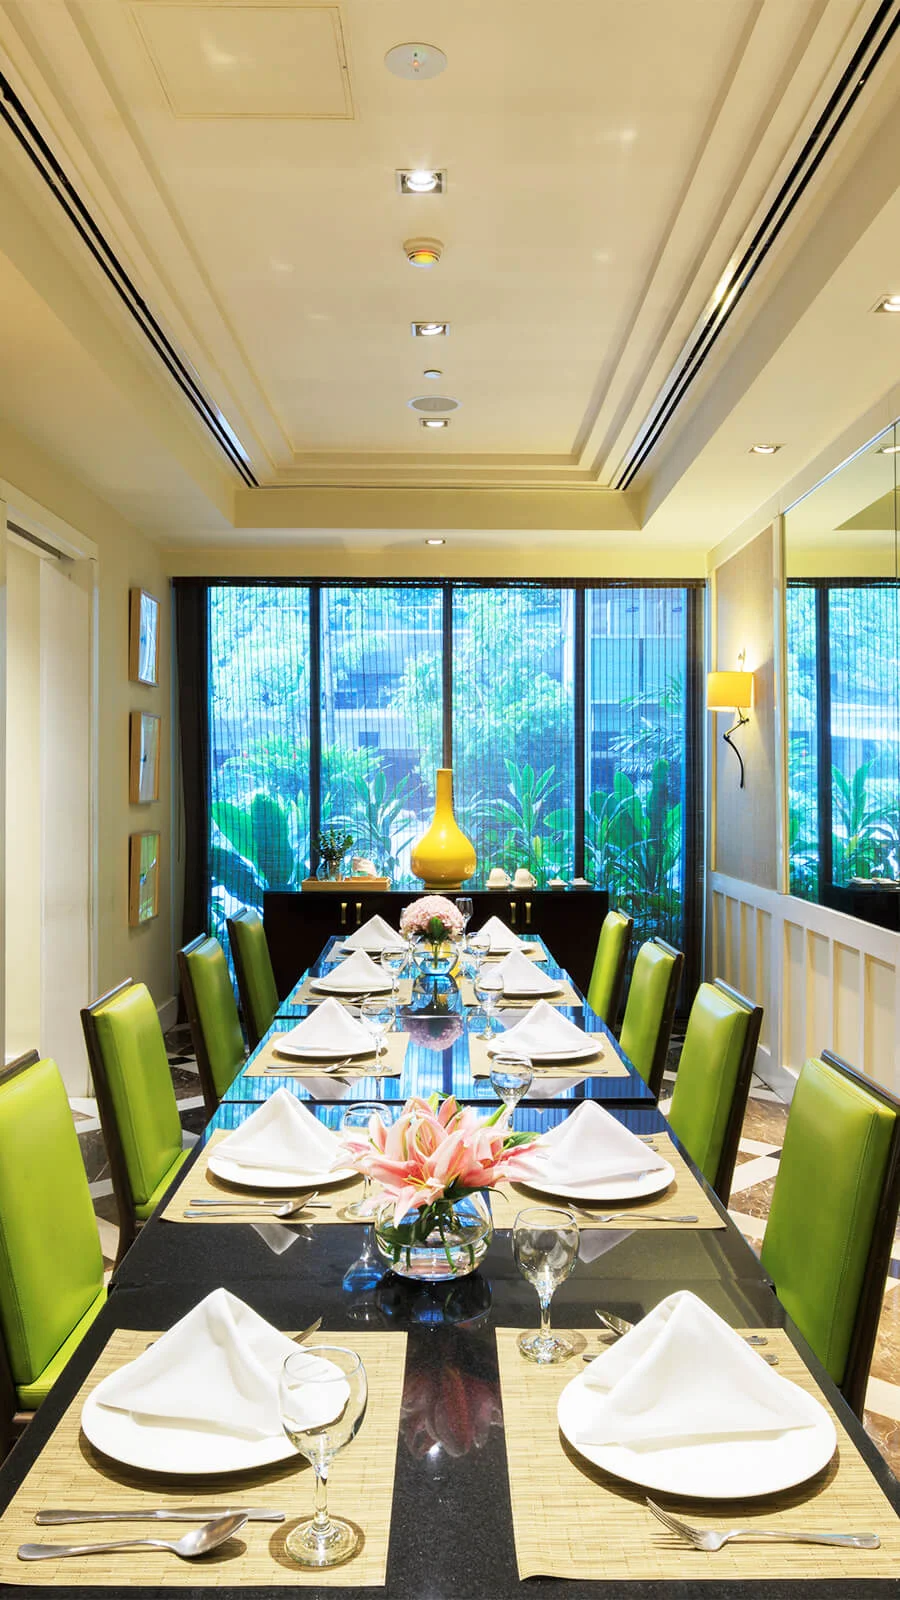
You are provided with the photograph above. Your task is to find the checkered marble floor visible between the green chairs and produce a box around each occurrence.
[74,1026,900,1477]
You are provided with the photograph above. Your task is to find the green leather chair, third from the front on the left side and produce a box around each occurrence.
[178,934,245,1117]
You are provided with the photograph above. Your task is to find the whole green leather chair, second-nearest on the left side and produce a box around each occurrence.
[82,978,187,1266]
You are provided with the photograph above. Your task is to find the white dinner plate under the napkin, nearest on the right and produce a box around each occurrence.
[557,1373,838,1499]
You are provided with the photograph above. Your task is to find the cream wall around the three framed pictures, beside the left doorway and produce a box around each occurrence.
[0,422,176,1008]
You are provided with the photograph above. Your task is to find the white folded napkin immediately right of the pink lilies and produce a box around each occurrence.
[519,1101,668,1192]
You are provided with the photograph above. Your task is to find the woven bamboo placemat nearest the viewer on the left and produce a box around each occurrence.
[0,1328,407,1590]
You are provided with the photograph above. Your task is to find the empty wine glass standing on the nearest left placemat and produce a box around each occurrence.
[279,1344,368,1566]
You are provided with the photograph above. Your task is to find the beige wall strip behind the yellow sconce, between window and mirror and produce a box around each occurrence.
[709,528,778,888]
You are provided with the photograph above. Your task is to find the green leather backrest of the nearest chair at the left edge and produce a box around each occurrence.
[0,1054,102,1384]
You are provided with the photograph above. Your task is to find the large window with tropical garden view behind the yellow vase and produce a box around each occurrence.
[208,582,697,942]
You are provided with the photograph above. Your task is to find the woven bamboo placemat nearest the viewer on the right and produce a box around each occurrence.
[496,1328,900,1594]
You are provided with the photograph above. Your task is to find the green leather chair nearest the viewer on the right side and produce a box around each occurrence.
[761,1051,900,1418]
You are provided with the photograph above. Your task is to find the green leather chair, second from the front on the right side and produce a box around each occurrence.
[669,978,762,1205]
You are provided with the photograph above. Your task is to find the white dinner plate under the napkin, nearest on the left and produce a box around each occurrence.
[82,1373,296,1478]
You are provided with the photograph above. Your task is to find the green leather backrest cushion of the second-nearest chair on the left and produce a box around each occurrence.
[91,984,181,1205]
